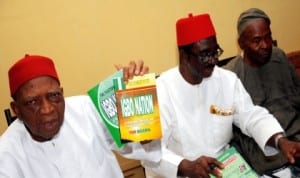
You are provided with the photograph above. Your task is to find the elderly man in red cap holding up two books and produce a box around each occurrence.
[0,55,160,178]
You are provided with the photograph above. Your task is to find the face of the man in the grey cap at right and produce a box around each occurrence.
[239,19,273,66]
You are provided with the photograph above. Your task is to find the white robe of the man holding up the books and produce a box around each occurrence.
[0,96,160,178]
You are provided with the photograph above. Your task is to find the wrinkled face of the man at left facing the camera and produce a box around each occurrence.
[11,76,65,141]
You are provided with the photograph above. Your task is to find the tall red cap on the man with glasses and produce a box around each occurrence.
[176,14,216,46]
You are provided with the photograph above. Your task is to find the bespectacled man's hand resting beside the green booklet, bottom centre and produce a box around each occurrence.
[178,156,224,178]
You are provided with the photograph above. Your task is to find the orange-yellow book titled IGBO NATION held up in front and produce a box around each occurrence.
[115,73,162,142]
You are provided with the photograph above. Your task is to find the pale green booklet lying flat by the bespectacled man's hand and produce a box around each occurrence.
[210,147,259,178]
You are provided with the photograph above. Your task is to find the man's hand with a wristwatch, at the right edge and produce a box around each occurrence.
[278,137,300,164]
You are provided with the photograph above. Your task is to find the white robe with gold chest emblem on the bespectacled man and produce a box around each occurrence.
[143,67,283,178]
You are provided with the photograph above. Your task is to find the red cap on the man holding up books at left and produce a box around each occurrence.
[8,54,59,96]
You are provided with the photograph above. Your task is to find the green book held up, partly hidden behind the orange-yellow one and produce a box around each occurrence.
[88,70,123,148]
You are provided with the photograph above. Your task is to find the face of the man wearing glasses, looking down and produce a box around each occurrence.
[180,37,222,84]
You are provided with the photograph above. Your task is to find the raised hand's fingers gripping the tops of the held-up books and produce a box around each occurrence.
[115,60,149,82]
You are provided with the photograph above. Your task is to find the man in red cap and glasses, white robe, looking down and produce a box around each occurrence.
[143,14,300,178]
